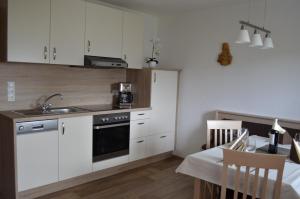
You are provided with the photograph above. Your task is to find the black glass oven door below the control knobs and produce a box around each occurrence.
[93,123,130,162]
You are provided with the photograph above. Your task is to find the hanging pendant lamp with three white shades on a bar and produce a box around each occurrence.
[235,0,274,49]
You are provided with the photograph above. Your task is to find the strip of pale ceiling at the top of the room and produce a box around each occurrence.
[101,0,248,14]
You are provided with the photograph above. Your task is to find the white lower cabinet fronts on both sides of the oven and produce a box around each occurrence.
[17,112,175,192]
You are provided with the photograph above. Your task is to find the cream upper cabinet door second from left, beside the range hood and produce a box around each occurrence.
[50,0,85,65]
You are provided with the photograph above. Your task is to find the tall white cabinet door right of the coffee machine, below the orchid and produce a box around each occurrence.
[150,70,178,134]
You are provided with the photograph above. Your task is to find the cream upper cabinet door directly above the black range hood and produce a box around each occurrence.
[85,1,123,58]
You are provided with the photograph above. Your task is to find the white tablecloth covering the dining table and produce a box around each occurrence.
[176,136,300,199]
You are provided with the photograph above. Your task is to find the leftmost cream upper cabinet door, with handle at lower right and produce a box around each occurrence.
[7,0,50,63]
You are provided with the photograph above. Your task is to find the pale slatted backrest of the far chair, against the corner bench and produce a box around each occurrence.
[206,120,242,149]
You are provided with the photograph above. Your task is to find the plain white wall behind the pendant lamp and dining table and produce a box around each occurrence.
[159,0,300,156]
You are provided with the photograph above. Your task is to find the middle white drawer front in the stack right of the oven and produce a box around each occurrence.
[130,119,149,139]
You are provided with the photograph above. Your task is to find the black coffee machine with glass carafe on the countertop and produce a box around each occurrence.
[117,83,133,108]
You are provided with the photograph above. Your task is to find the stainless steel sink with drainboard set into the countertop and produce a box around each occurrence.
[14,107,85,115]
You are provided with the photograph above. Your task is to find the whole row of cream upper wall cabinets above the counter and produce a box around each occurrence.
[4,0,148,69]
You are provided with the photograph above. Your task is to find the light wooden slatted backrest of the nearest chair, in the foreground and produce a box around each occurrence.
[221,149,286,199]
